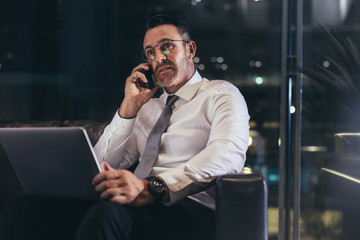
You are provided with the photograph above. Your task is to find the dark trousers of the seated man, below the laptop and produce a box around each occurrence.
[0,197,215,240]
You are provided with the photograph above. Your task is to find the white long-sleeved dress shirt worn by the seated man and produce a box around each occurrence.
[95,71,249,209]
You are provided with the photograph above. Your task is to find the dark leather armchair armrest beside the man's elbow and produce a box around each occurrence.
[216,168,268,240]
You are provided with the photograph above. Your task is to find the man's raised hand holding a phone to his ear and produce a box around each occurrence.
[119,63,158,118]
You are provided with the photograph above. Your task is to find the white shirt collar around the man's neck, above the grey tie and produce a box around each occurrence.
[164,71,203,101]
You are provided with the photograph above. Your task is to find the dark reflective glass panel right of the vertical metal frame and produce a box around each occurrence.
[301,0,360,240]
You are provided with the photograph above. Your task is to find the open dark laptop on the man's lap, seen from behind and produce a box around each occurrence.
[0,127,101,200]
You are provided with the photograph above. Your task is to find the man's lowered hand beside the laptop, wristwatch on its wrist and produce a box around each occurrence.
[93,162,154,207]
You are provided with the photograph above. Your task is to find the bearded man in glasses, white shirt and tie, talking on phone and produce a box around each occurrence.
[0,15,249,240]
